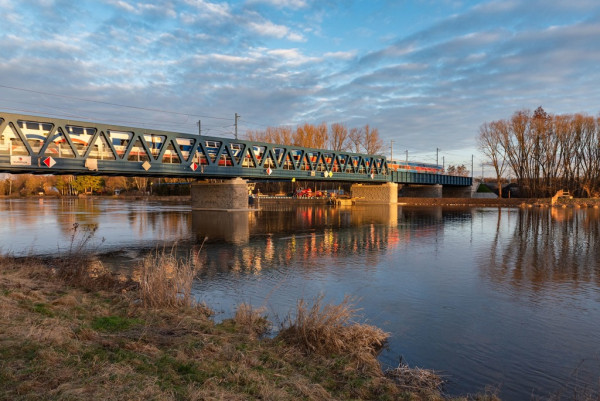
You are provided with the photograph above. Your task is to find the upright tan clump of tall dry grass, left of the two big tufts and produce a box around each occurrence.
[139,249,198,308]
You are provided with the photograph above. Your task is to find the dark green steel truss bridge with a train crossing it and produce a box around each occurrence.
[0,112,472,186]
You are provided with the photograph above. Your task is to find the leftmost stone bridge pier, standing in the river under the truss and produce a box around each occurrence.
[191,178,248,211]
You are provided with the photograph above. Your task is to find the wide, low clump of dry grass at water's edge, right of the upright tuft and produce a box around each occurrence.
[278,295,389,370]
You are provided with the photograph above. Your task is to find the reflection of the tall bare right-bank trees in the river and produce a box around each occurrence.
[481,209,600,289]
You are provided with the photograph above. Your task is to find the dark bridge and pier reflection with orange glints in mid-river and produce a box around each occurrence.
[197,205,441,277]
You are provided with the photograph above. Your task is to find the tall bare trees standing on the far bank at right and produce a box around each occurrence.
[478,106,600,197]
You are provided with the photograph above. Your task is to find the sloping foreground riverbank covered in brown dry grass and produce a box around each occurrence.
[0,254,502,400]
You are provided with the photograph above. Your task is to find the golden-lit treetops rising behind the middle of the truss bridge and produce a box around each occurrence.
[246,123,383,155]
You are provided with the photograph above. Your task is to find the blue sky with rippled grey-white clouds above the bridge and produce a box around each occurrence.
[0,0,600,175]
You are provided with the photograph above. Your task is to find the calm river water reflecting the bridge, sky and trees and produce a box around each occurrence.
[0,199,600,400]
